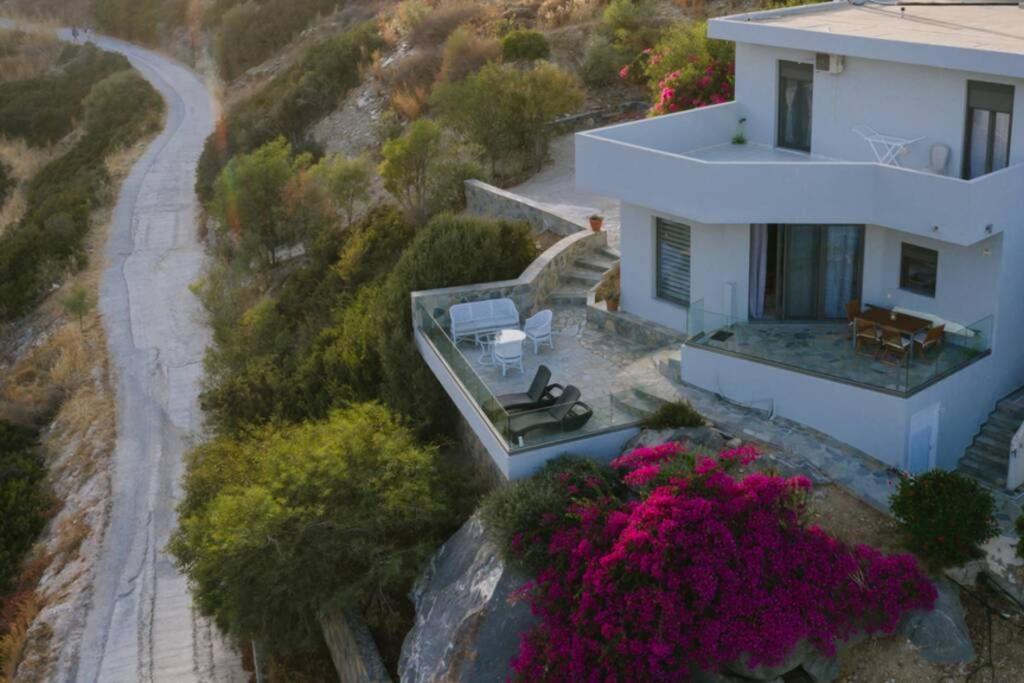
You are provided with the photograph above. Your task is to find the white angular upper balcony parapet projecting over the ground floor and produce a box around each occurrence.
[575,102,1024,246]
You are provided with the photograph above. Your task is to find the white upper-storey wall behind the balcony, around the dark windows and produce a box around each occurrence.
[736,43,1024,176]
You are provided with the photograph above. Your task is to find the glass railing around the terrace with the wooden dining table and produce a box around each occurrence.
[686,301,994,395]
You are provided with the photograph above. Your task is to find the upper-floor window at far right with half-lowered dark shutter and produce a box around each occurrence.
[964,81,1014,178]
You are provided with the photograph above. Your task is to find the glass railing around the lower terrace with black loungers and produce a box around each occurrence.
[415,301,654,454]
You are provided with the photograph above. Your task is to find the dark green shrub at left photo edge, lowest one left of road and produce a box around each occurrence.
[0,420,50,595]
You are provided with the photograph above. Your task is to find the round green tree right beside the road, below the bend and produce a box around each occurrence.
[210,137,314,267]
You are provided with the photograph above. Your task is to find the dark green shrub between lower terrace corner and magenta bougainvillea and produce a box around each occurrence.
[480,456,625,571]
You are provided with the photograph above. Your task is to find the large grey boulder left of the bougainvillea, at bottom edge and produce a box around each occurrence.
[398,514,535,683]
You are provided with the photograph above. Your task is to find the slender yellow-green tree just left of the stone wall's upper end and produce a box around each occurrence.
[380,119,480,225]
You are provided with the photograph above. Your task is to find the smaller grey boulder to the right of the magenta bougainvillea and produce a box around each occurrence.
[899,579,975,664]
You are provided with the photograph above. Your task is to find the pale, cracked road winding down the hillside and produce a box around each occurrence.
[41,29,247,683]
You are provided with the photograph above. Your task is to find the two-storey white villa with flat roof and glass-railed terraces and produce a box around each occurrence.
[414,2,1024,487]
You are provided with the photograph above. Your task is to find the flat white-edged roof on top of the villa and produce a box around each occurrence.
[709,0,1024,78]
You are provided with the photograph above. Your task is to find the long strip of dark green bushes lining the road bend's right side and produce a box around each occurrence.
[196,23,381,202]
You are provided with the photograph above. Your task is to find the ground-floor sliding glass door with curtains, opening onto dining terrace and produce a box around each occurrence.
[751,225,864,321]
